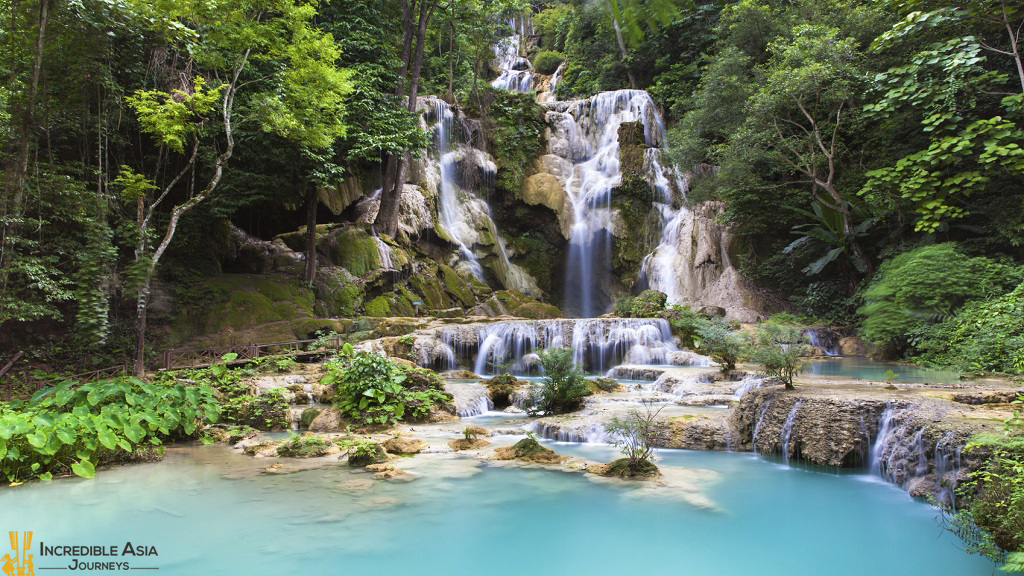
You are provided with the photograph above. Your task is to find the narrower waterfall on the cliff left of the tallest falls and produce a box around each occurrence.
[428,98,542,298]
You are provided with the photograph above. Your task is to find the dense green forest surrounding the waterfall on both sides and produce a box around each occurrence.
[0,0,1024,373]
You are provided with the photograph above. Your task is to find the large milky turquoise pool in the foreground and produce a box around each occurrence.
[0,445,992,576]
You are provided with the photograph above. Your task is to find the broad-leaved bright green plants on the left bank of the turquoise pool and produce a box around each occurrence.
[0,378,220,483]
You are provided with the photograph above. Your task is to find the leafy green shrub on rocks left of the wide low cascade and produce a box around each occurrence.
[321,352,450,425]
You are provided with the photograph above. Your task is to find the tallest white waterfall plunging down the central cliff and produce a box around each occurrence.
[548,90,668,318]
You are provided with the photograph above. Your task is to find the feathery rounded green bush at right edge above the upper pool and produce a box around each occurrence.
[860,243,1021,351]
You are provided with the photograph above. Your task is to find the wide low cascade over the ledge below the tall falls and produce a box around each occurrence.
[440,318,678,375]
